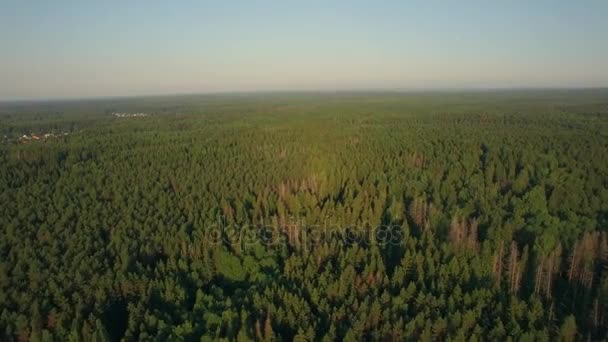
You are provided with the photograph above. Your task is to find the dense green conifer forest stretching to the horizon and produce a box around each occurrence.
[0,90,608,341]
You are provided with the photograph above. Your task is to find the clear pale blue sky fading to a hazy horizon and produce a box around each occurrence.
[0,0,608,100]
